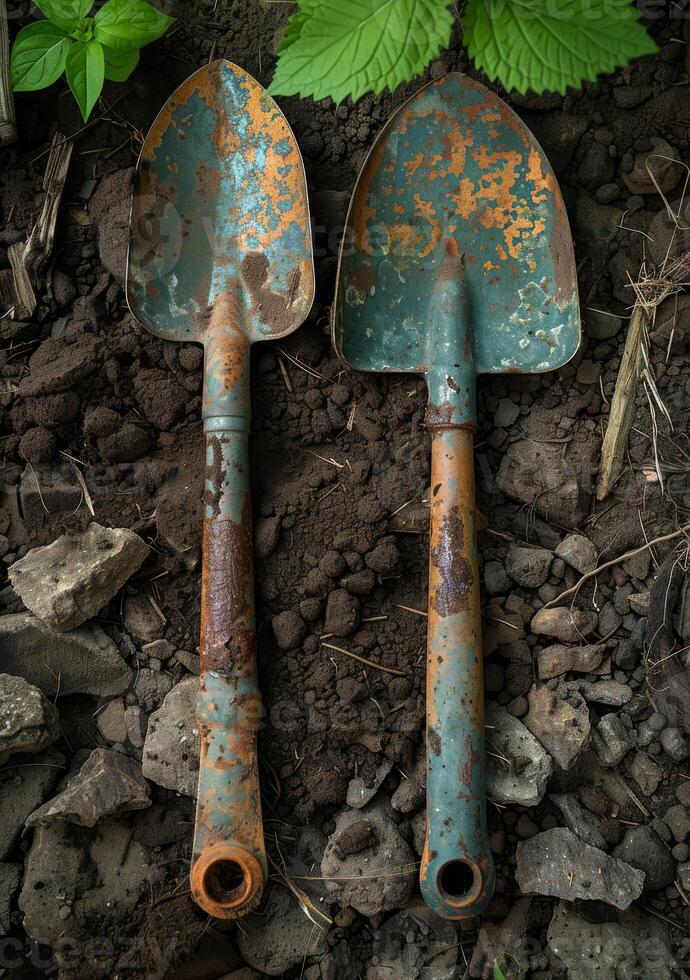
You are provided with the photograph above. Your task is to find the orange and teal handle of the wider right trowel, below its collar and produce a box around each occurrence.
[420,425,494,919]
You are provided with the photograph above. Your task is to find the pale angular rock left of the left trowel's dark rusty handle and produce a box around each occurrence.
[9,522,149,633]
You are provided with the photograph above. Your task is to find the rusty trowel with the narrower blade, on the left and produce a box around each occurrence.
[127,61,314,918]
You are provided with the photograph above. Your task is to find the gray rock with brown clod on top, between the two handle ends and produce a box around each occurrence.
[321,800,417,915]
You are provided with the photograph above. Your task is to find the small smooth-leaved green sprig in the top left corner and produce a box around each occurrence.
[12,0,174,122]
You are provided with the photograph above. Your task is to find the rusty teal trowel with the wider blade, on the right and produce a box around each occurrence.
[333,74,580,919]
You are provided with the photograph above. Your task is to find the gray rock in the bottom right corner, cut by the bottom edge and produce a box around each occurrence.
[547,902,682,980]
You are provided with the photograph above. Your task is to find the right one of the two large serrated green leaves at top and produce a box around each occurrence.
[464,0,657,94]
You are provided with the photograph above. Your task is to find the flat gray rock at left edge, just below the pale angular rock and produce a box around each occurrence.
[0,613,132,697]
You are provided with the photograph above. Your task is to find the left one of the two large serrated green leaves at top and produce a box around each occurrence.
[269,0,453,102]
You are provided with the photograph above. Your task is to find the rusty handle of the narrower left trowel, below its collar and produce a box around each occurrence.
[191,416,267,919]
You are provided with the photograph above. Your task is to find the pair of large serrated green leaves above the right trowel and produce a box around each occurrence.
[270,0,656,102]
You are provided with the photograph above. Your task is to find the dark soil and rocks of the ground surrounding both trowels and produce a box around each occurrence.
[0,0,690,980]
